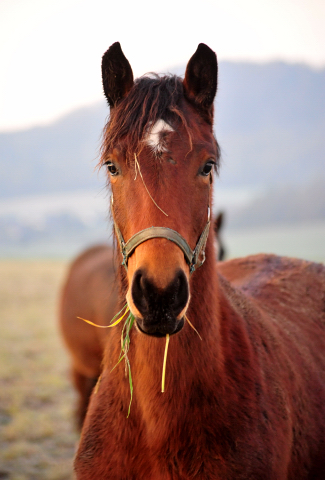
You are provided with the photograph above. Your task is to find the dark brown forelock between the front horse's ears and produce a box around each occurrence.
[100,73,219,165]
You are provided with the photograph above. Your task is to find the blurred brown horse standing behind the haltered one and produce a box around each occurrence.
[60,212,225,428]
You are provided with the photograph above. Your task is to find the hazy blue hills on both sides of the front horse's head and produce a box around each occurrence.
[0,62,325,198]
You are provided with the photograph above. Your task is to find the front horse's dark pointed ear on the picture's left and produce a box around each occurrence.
[102,42,133,107]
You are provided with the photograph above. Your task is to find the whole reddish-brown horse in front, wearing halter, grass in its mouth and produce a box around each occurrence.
[64,43,325,480]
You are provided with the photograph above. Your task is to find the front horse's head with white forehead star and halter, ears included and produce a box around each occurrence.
[101,43,219,337]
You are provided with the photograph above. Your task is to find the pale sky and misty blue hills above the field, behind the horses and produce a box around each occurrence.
[0,0,325,261]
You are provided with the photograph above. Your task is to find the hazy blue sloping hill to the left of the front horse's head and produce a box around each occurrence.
[0,102,108,197]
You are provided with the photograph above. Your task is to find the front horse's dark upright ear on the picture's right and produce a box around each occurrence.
[183,43,218,110]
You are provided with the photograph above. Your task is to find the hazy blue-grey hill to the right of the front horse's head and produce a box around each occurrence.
[216,63,325,187]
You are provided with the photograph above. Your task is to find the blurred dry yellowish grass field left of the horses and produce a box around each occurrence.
[0,260,78,480]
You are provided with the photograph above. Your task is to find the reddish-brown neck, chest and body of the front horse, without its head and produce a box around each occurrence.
[77,255,325,480]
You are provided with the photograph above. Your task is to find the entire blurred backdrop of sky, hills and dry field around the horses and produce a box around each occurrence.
[0,0,325,480]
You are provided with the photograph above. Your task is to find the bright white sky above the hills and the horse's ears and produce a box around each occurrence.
[0,0,325,131]
